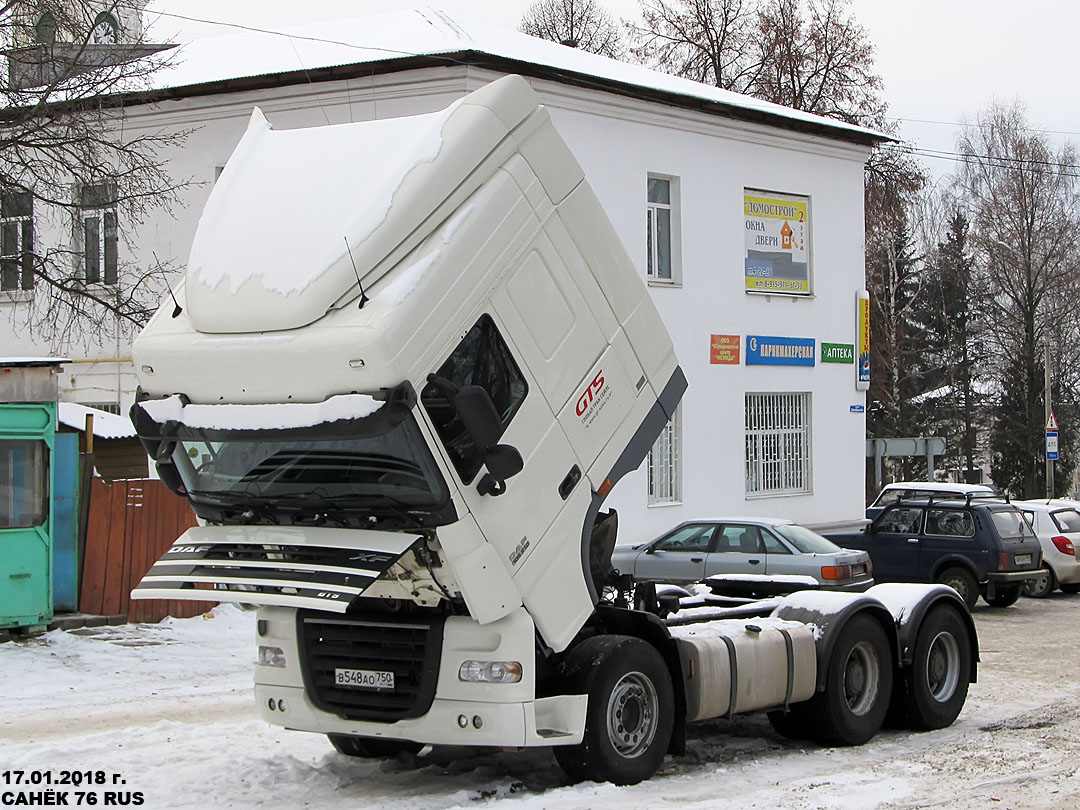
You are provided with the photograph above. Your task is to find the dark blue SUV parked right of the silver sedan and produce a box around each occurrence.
[828,497,1042,607]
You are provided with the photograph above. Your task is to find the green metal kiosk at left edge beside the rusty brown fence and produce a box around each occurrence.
[0,357,64,630]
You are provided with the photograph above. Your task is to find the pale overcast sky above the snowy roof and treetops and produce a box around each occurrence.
[148,0,1080,182]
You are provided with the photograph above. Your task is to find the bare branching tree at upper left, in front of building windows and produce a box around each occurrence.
[0,0,185,348]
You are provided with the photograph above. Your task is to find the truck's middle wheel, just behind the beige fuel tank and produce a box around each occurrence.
[807,615,893,745]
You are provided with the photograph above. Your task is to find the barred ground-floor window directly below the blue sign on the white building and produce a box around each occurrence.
[746,393,811,495]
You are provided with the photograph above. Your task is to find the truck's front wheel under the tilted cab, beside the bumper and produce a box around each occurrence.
[555,635,675,785]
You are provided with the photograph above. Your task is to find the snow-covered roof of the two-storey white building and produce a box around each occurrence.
[141,8,890,143]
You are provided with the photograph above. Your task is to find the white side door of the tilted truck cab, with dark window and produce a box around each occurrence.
[420,311,581,576]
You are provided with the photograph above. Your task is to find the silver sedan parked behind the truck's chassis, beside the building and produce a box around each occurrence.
[611,517,874,596]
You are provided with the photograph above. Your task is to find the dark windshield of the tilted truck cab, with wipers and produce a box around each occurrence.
[173,416,449,526]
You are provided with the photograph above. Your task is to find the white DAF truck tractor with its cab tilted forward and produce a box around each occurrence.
[132,77,978,784]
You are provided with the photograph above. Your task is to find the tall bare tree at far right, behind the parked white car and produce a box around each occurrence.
[957,105,1080,497]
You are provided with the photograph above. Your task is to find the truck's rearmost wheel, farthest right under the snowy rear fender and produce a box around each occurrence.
[904,605,971,730]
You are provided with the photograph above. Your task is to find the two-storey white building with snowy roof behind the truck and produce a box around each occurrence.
[0,10,881,542]
